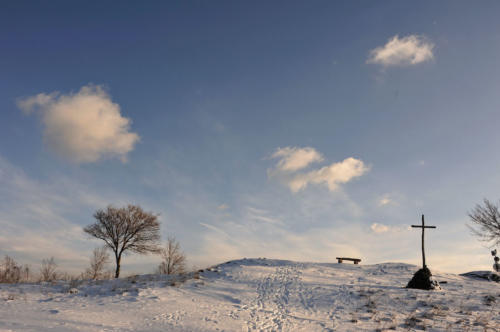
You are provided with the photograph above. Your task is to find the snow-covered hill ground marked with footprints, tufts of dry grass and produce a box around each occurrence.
[0,259,500,331]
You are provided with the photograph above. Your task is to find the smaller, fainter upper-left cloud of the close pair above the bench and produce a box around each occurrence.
[271,147,323,172]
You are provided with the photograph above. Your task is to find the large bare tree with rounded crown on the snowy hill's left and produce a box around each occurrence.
[83,205,160,278]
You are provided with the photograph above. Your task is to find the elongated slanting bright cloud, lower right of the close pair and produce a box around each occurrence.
[288,157,370,192]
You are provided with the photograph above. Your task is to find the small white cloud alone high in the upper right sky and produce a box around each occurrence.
[366,35,434,67]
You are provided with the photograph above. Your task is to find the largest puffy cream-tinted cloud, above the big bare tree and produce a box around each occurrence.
[18,85,139,163]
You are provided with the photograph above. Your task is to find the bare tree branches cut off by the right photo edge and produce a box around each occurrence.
[468,198,500,246]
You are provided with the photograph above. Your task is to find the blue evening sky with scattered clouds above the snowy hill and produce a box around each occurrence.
[0,1,500,273]
